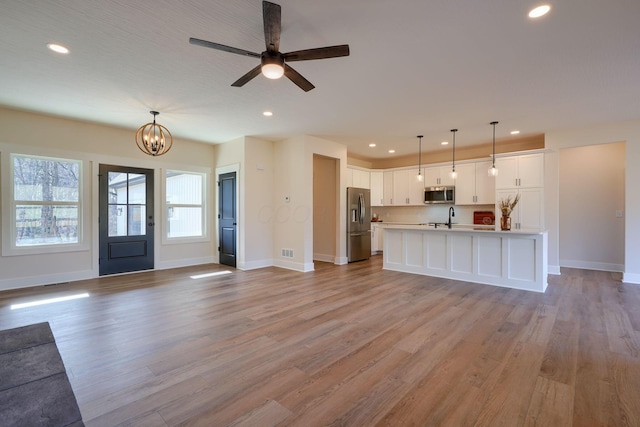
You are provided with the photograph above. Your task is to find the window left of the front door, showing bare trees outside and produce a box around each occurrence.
[11,154,81,247]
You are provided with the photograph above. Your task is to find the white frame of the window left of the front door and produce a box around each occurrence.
[0,151,87,256]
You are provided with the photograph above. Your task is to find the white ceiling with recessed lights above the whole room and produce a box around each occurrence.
[0,0,640,159]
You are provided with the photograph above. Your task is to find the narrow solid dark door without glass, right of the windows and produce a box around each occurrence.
[218,172,237,267]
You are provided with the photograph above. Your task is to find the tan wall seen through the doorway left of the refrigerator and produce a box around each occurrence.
[313,155,338,262]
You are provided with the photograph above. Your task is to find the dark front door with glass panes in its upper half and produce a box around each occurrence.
[99,165,154,276]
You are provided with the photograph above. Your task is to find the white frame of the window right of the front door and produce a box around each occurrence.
[161,168,209,244]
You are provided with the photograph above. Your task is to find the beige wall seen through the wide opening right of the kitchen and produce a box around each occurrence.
[559,142,625,271]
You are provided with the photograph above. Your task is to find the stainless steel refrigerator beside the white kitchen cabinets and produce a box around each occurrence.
[347,187,371,262]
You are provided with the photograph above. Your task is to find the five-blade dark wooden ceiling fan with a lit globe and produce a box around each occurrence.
[189,1,349,92]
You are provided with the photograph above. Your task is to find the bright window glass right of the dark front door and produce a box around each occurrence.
[165,171,205,239]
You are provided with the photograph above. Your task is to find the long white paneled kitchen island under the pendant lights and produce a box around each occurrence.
[383,224,547,292]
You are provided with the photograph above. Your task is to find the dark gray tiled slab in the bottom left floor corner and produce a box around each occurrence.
[0,323,84,427]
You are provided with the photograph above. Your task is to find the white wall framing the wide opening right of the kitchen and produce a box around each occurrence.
[545,120,640,284]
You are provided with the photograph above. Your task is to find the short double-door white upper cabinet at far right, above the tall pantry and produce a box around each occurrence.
[495,153,544,189]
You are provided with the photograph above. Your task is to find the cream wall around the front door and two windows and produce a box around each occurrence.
[0,108,214,290]
